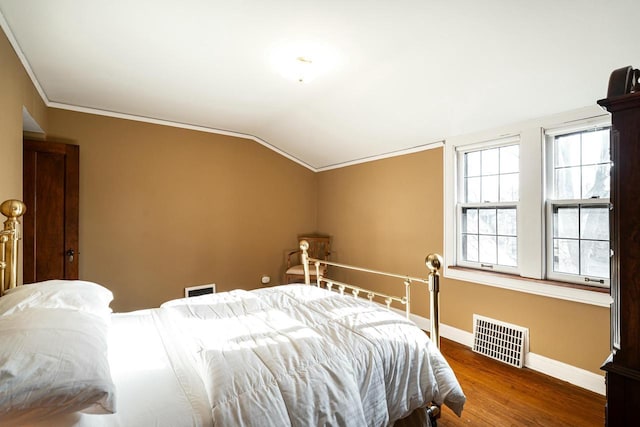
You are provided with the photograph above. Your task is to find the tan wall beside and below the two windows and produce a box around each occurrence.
[318,148,609,374]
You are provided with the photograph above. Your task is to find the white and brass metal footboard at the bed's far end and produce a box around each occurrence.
[300,240,443,349]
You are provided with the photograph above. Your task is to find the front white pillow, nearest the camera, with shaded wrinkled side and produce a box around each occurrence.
[0,308,115,425]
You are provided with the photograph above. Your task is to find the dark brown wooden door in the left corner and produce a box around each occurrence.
[22,140,80,283]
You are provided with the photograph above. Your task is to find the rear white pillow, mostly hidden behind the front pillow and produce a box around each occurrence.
[0,280,113,317]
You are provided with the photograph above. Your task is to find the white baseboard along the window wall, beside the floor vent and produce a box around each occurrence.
[397,310,606,396]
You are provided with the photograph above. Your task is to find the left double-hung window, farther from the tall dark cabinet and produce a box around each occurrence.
[458,144,520,272]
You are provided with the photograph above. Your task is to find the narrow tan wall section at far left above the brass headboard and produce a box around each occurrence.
[0,30,47,202]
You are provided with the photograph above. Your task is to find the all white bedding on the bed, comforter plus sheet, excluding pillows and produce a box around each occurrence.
[33,285,465,427]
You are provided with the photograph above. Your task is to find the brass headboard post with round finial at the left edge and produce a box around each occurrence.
[0,199,27,296]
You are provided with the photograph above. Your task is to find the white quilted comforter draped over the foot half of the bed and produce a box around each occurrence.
[162,285,465,426]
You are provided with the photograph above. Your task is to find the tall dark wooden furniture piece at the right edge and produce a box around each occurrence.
[598,67,640,427]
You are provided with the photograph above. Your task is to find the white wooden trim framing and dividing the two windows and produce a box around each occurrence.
[443,105,612,307]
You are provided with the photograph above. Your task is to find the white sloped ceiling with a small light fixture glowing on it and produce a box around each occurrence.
[0,0,640,170]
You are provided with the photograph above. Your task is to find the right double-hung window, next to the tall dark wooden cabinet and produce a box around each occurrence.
[547,128,611,286]
